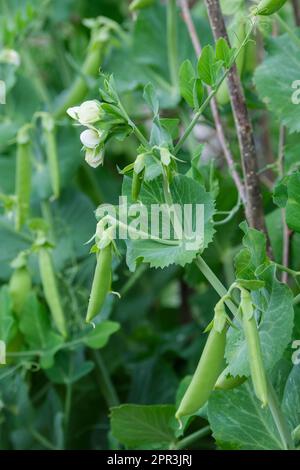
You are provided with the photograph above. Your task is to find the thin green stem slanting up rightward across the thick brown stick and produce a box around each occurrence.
[174,23,254,155]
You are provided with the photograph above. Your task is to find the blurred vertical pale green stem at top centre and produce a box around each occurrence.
[167,0,178,89]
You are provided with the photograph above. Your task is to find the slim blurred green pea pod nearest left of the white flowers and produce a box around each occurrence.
[42,114,60,198]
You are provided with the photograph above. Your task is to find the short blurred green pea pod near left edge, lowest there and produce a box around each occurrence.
[9,266,32,314]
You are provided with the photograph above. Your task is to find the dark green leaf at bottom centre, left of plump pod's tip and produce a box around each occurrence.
[111,405,178,449]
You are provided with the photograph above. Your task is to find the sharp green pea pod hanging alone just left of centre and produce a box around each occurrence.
[86,243,112,323]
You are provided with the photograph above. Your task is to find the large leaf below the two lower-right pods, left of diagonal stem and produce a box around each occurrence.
[208,383,282,450]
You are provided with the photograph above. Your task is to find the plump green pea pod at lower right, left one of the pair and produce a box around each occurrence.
[176,328,227,419]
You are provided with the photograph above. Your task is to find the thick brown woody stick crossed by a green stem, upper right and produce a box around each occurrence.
[205,0,269,239]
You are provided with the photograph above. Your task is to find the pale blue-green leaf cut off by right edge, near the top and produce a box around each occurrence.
[254,34,300,132]
